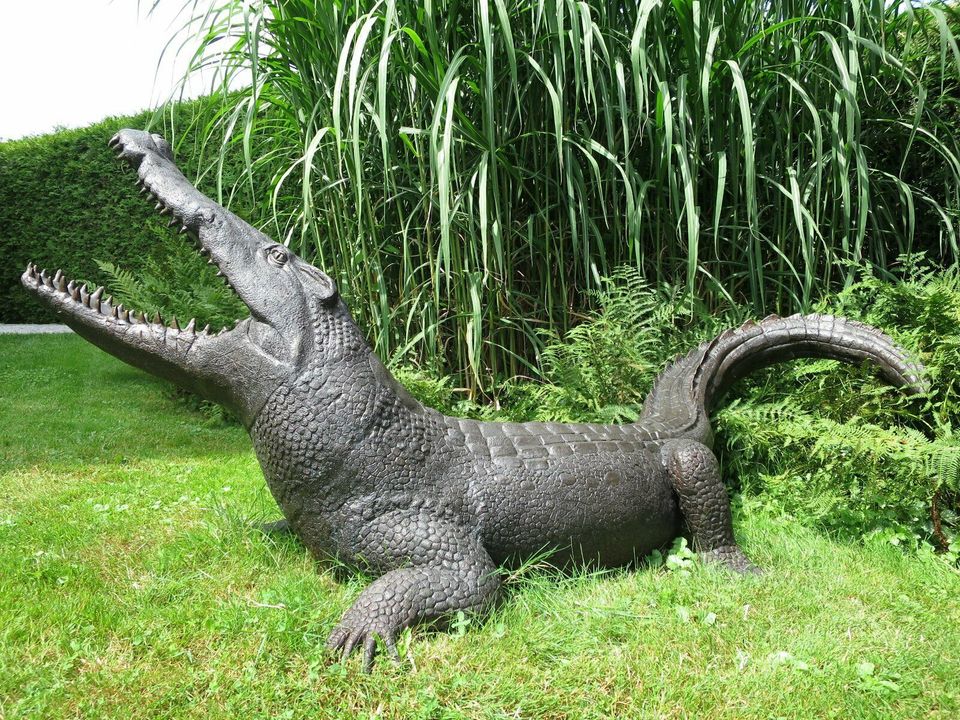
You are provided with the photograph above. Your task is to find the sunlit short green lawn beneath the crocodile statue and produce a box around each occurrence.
[0,336,960,720]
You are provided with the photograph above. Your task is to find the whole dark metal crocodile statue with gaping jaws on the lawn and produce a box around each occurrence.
[22,130,923,671]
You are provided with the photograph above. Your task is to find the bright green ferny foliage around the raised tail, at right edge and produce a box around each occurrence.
[715,256,960,550]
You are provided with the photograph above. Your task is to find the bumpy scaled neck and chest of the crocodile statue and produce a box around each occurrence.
[250,313,443,549]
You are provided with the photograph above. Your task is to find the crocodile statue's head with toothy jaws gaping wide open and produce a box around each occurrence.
[21,130,347,427]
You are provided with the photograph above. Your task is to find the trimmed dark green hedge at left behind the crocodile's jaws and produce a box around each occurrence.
[0,100,257,323]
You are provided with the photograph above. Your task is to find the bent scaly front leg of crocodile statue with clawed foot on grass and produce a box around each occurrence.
[327,511,500,672]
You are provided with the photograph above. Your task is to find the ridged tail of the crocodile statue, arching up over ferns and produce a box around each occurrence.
[638,315,925,445]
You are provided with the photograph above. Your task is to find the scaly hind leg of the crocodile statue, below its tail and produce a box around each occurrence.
[660,440,760,574]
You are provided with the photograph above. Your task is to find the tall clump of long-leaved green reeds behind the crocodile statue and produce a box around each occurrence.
[158,0,960,392]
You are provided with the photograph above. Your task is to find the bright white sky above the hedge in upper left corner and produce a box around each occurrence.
[0,0,229,140]
